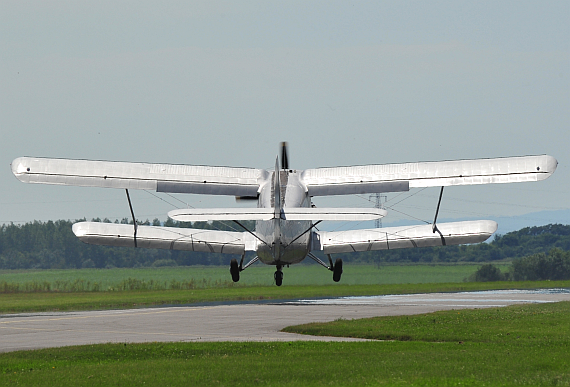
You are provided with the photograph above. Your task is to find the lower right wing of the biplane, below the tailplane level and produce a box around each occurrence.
[313,220,497,254]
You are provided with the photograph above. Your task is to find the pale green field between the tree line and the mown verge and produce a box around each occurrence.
[0,264,510,292]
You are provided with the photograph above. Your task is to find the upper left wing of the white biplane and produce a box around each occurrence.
[12,157,266,196]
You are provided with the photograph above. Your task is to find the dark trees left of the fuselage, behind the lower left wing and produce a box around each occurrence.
[0,218,246,269]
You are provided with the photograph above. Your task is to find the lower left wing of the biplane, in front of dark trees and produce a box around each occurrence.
[73,222,246,254]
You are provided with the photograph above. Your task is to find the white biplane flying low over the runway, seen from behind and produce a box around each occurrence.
[11,143,558,286]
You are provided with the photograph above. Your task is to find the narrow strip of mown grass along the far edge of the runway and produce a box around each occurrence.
[0,281,570,313]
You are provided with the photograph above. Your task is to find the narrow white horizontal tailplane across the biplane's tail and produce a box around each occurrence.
[168,207,387,222]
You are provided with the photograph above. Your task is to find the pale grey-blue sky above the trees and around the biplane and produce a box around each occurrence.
[0,0,570,227]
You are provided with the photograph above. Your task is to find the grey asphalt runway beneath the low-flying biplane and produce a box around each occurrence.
[0,289,570,352]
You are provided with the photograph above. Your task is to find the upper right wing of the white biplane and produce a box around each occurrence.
[302,155,558,196]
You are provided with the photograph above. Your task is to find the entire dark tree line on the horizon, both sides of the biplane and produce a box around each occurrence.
[0,218,570,269]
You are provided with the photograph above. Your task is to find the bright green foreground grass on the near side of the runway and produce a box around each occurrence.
[0,302,570,386]
